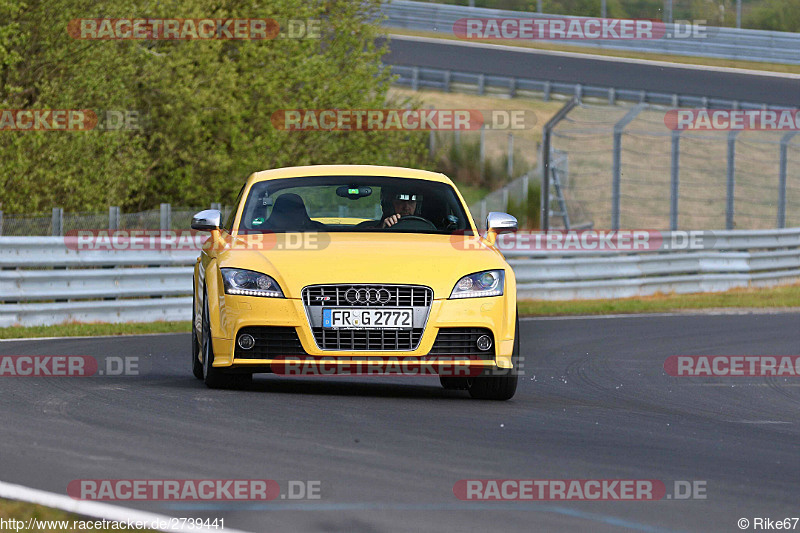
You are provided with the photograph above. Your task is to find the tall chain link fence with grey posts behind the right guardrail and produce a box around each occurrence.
[548,103,800,230]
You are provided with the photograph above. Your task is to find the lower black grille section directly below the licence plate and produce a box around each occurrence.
[312,328,423,351]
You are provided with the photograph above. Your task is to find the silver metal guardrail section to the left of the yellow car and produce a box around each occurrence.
[0,237,198,327]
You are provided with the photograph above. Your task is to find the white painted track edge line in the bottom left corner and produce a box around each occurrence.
[0,481,253,533]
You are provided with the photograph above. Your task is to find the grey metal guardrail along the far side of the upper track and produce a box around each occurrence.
[381,0,800,65]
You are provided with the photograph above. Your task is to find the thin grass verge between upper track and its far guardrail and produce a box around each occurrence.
[387,28,800,74]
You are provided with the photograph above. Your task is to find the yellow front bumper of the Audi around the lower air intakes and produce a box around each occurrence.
[212,295,516,372]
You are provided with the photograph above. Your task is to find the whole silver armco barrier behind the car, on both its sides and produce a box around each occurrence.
[0,228,800,327]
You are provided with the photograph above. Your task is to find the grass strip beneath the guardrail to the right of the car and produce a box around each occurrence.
[519,284,800,316]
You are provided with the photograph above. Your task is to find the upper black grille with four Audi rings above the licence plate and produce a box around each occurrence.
[303,285,433,307]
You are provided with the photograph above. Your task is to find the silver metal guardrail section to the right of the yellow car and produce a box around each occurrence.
[505,228,800,300]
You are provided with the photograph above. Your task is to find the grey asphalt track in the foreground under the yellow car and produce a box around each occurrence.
[0,314,800,532]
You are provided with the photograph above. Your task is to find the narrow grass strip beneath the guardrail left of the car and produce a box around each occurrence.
[0,321,192,339]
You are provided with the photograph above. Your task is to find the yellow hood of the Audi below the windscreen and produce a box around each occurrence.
[219,233,508,299]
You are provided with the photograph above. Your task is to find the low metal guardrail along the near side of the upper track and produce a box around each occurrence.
[391,65,781,109]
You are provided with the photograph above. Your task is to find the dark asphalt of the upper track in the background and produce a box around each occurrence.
[384,36,800,107]
